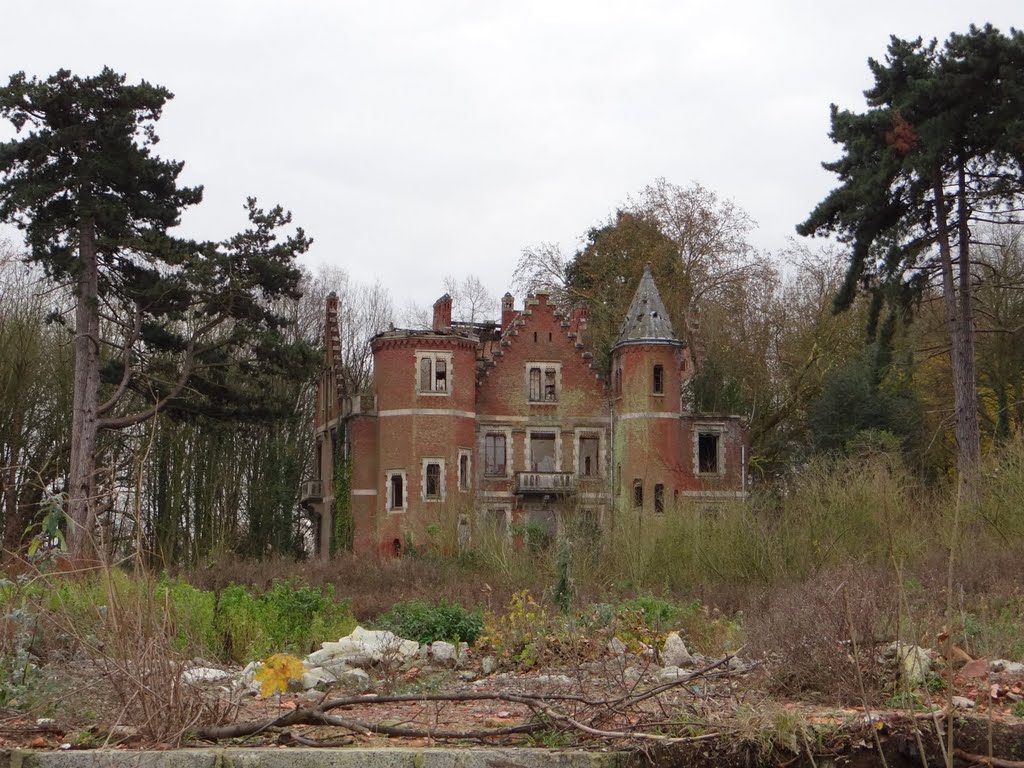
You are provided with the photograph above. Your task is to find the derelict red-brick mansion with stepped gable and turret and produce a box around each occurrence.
[303,267,748,557]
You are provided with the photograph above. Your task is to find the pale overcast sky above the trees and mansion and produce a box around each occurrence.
[0,0,1024,313]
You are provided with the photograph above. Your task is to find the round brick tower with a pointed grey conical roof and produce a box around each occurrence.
[611,264,685,514]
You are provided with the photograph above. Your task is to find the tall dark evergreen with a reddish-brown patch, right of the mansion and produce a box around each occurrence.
[797,26,1024,487]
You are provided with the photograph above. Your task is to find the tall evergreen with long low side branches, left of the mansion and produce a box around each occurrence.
[0,69,309,556]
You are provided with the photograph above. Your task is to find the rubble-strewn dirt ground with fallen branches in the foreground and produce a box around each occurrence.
[0,654,1024,768]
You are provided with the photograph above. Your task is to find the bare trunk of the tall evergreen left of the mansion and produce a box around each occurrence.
[68,220,99,559]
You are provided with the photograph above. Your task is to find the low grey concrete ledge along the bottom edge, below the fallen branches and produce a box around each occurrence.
[0,746,633,768]
